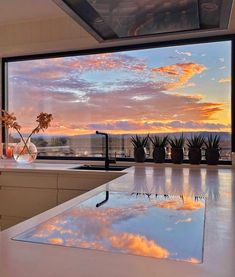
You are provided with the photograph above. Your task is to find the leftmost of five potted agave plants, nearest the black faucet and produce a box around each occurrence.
[131,135,149,163]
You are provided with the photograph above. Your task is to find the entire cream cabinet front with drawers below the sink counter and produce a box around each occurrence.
[0,170,123,229]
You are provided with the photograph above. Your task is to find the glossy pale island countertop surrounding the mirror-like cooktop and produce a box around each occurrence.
[0,165,235,277]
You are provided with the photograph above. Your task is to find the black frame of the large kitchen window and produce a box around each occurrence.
[1,34,235,164]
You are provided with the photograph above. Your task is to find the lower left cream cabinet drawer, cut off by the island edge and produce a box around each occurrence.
[0,186,57,218]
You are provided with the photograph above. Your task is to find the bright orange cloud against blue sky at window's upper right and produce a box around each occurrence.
[152,63,206,89]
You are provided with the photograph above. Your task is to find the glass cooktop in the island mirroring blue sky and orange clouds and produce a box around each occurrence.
[14,192,205,263]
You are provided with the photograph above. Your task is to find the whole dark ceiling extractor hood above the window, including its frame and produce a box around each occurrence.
[53,0,233,42]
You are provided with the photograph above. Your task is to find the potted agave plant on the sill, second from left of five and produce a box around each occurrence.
[149,136,168,163]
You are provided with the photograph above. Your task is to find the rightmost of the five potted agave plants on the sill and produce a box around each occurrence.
[205,134,220,165]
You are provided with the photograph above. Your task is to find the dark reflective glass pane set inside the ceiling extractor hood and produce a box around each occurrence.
[88,0,200,38]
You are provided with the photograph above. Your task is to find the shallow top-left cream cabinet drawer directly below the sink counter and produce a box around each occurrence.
[0,172,57,188]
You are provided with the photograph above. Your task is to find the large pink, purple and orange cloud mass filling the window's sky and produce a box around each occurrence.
[9,53,226,134]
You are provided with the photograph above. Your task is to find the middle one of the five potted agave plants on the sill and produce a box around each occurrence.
[168,134,185,164]
